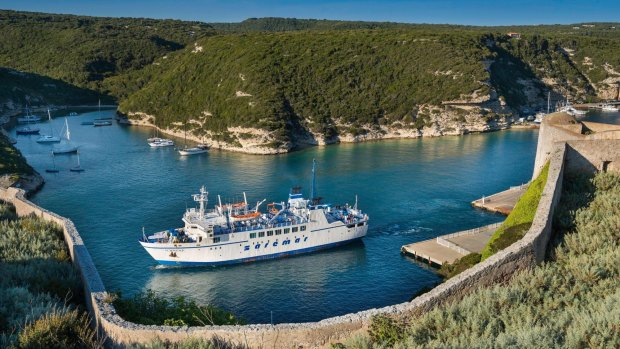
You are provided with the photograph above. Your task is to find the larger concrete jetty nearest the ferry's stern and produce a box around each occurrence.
[400,222,502,266]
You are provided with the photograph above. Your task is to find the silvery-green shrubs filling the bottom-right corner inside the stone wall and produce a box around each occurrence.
[343,169,620,348]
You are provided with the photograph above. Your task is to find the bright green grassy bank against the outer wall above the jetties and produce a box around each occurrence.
[481,163,549,261]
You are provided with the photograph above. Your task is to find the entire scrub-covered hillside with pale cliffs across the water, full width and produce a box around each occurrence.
[0,11,620,150]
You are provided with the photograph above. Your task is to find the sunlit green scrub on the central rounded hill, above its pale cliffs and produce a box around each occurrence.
[120,30,490,145]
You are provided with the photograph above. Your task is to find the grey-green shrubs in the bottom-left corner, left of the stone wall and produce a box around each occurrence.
[0,202,102,348]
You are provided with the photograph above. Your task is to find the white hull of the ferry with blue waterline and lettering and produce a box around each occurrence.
[140,221,368,266]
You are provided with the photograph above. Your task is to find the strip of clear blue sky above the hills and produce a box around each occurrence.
[0,0,620,25]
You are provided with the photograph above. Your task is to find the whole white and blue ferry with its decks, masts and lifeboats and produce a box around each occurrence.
[140,160,368,266]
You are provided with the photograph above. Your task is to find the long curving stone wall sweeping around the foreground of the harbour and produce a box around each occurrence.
[0,143,567,348]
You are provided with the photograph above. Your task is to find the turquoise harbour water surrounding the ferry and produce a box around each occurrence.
[12,111,538,323]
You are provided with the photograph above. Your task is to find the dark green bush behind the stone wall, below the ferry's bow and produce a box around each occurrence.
[113,290,243,326]
